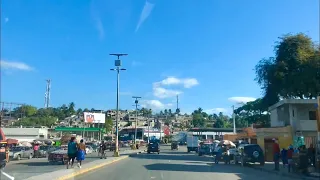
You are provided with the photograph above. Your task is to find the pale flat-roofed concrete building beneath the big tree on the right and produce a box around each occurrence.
[269,99,317,136]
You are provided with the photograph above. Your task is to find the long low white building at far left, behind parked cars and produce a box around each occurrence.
[2,127,48,142]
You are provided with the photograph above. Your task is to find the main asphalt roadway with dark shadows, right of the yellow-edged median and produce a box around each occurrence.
[74,146,290,180]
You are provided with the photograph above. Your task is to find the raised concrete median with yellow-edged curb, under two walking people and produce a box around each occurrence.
[26,149,144,180]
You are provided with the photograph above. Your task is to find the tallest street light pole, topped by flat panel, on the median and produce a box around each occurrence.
[110,54,128,157]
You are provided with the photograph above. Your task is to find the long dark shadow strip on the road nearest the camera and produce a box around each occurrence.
[144,163,245,179]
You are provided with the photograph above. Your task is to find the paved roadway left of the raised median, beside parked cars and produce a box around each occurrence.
[0,148,128,180]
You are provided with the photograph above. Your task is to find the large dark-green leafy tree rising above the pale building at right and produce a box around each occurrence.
[255,33,320,106]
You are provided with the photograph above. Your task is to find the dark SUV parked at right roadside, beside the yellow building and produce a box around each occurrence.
[235,144,265,166]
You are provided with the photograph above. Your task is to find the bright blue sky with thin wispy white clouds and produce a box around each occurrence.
[1,0,319,113]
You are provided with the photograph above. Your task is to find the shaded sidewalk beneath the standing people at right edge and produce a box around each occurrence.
[249,162,320,180]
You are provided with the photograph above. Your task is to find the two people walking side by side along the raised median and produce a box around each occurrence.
[67,137,86,168]
